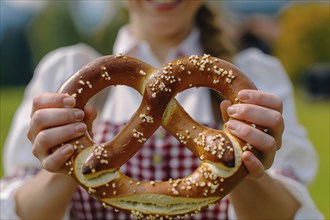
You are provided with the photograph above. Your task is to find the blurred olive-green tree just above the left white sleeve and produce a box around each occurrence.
[28,1,127,64]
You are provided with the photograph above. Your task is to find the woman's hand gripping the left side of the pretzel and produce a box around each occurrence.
[28,93,96,173]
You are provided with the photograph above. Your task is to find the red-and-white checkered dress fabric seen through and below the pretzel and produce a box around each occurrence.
[71,122,228,220]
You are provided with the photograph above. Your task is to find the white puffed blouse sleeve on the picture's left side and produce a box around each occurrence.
[0,44,100,219]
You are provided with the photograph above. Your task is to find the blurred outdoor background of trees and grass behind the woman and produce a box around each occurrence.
[0,0,330,219]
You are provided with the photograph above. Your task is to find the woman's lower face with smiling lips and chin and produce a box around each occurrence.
[126,0,203,37]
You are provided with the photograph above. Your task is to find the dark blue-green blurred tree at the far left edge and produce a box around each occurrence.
[0,1,33,86]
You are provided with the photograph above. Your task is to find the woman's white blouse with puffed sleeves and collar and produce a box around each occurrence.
[0,26,323,219]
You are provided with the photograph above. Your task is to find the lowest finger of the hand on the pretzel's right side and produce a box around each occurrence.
[242,151,265,178]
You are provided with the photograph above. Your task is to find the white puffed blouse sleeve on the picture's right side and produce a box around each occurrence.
[228,48,323,219]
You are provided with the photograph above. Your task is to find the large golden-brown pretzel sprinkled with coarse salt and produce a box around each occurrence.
[59,55,257,218]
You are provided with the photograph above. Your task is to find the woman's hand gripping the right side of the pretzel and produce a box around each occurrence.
[221,90,284,178]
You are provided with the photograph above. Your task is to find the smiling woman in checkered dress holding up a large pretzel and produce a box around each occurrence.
[2,0,320,219]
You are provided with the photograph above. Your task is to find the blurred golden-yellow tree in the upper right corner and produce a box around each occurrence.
[274,2,330,81]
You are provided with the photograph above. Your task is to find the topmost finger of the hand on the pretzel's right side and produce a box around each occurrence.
[238,90,283,113]
